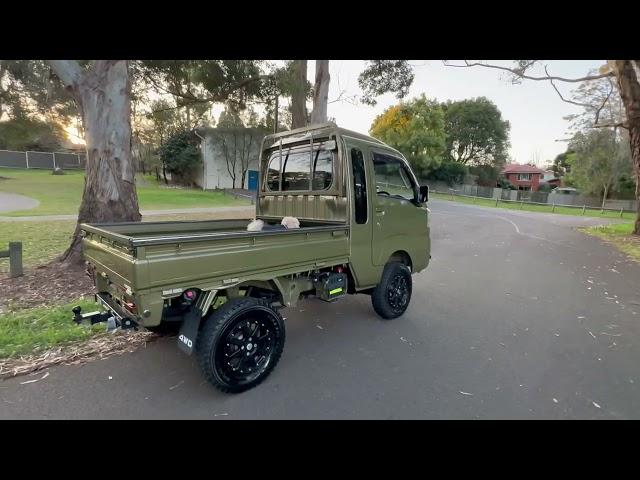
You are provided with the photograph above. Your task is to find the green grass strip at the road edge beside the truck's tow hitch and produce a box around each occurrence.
[0,300,105,359]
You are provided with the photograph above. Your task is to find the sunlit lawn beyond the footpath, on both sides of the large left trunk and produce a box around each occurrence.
[0,168,250,217]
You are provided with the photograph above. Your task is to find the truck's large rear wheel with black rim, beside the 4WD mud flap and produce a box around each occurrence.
[196,297,285,393]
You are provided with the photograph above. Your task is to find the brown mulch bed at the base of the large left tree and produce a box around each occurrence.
[0,260,94,314]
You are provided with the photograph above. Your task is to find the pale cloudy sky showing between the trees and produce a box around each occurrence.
[316,60,604,165]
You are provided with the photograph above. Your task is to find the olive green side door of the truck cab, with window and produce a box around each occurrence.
[369,150,427,265]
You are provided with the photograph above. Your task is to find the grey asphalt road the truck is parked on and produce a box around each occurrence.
[0,201,640,419]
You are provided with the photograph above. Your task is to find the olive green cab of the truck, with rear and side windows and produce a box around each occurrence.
[257,123,431,291]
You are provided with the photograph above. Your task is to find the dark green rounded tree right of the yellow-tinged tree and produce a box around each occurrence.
[443,97,510,166]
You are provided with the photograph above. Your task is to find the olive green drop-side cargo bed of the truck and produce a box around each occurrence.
[82,219,349,293]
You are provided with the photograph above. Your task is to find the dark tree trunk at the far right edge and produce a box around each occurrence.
[615,60,640,235]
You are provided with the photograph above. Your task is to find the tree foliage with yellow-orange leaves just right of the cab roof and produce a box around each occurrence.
[370,94,446,175]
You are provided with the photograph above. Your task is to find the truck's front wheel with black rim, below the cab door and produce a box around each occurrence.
[371,262,412,320]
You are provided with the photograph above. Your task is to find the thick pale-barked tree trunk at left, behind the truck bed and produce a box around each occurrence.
[49,60,141,263]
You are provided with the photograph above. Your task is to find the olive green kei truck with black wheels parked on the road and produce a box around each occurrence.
[73,123,431,393]
